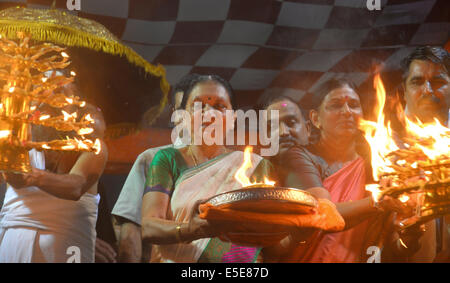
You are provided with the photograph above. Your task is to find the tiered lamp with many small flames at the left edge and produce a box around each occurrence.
[0,32,100,172]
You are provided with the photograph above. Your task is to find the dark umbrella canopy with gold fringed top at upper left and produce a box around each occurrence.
[0,7,169,135]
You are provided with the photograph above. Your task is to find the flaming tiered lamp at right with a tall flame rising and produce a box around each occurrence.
[360,75,450,227]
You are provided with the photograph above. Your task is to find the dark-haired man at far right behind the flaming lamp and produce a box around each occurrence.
[402,46,450,262]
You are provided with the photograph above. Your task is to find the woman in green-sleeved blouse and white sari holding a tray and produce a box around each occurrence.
[142,76,271,262]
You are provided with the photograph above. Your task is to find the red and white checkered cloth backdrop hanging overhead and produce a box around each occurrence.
[0,0,450,115]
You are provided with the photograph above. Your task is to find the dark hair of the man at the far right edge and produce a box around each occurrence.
[401,46,450,80]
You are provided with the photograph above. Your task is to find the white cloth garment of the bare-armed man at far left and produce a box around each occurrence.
[0,149,100,262]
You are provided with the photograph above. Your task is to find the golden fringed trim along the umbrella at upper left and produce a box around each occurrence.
[0,7,170,125]
